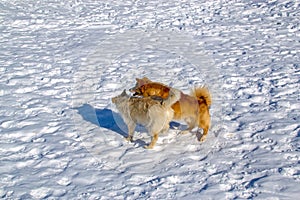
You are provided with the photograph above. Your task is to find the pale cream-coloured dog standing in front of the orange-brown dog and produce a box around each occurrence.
[112,89,180,149]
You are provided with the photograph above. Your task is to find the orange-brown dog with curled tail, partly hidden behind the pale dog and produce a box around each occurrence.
[129,77,212,142]
